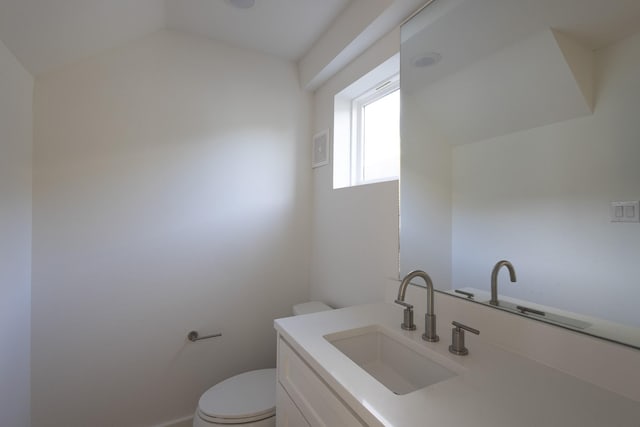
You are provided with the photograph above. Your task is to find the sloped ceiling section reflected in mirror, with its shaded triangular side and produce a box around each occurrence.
[405,29,594,145]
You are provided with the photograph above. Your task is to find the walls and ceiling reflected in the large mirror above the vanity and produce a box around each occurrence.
[400,0,640,346]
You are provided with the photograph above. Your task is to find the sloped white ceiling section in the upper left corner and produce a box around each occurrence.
[0,0,165,76]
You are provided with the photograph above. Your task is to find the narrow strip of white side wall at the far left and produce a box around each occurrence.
[0,37,33,427]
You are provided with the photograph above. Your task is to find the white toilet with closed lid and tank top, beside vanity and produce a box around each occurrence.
[193,301,331,427]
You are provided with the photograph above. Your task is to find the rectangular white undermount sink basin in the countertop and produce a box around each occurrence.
[324,325,457,395]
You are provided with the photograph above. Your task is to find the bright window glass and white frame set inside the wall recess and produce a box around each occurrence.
[351,76,400,185]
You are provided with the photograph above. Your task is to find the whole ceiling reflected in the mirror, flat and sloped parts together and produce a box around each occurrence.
[400,0,640,145]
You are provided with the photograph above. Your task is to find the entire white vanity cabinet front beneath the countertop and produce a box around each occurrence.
[276,336,367,427]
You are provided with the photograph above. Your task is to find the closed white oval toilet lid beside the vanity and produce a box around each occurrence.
[198,368,276,419]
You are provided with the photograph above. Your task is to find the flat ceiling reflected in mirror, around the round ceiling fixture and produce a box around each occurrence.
[402,0,640,93]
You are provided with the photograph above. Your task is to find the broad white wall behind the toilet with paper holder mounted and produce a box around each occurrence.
[32,31,311,427]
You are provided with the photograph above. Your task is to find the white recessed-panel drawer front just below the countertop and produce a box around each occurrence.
[277,338,366,427]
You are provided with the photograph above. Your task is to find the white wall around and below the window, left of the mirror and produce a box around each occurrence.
[310,30,400,307]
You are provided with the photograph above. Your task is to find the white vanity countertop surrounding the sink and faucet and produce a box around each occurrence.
[275,304,640,427]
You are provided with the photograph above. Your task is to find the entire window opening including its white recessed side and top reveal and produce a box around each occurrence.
[333,55,400,188]
